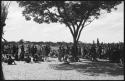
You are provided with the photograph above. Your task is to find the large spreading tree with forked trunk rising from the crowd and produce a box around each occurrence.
[18,0,121,61]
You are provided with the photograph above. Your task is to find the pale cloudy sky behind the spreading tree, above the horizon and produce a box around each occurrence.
[3,1,124,43]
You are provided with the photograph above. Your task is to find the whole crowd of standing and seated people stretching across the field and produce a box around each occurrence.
[2,43,124,63]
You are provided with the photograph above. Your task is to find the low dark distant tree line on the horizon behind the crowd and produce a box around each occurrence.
[2,38,124,46]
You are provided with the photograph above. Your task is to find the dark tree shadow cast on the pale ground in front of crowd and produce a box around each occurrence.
[49,61,124,76]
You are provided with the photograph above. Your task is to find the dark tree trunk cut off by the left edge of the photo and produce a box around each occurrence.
[0,1,10,80]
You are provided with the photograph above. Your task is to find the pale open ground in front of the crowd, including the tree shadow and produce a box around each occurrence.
[2,58,124,80]
